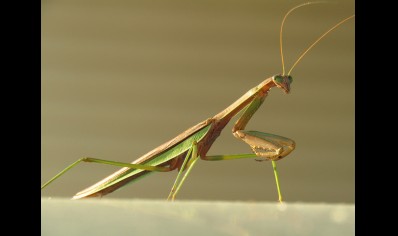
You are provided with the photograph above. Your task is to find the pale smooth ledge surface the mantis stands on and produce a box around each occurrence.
[41,198,355,236]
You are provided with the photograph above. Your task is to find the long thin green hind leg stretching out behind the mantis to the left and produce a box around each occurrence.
[41,157,170,189]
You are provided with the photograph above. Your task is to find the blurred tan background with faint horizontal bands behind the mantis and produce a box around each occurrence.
[41,0,355,203]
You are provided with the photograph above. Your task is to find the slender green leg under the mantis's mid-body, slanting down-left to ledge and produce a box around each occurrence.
[167,142,199,201]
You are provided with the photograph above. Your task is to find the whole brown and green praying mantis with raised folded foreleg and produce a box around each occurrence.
[41,2,354,202]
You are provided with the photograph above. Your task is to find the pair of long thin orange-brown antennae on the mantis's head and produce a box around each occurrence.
[279,2,355,75]
